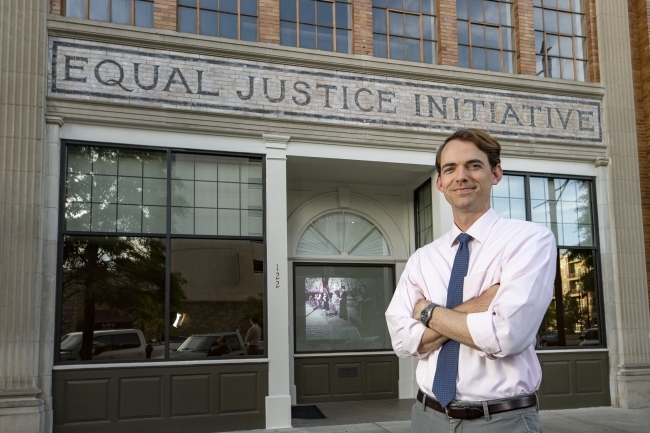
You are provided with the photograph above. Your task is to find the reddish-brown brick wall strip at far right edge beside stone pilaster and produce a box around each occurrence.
[624,0,650,307]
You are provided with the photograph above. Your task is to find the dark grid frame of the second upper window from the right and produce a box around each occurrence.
[456,0,517,74]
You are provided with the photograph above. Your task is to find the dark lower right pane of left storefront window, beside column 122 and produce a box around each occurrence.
[169,238,265,361]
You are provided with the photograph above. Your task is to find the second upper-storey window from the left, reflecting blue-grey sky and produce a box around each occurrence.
[178,0,257,42]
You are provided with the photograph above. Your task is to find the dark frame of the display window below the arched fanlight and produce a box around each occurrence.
[291,259,397,357]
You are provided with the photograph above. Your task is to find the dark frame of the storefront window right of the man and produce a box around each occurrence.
[496,170,607,352]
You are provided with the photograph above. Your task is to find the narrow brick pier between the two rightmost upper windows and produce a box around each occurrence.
[514,0,537,75]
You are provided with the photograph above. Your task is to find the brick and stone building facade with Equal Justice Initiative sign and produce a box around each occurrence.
[0,0,650,432]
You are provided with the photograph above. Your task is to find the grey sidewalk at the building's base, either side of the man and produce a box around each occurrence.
[228,400,650,433]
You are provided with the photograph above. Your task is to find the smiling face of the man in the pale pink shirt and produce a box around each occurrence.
[436,140,503,214]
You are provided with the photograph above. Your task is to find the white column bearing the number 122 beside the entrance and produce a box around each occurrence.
[262,134,292,429]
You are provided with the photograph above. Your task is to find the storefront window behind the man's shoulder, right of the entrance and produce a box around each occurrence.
[492,174,604,348]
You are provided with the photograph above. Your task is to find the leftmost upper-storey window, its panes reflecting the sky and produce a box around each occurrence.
[65,0,153,28]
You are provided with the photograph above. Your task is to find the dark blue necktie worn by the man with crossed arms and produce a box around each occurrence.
[433,233,472,407]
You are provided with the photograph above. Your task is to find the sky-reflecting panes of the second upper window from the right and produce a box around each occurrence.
[456,0,515,73]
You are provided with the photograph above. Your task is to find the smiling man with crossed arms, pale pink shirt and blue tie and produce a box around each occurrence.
[386,129,557,433]
